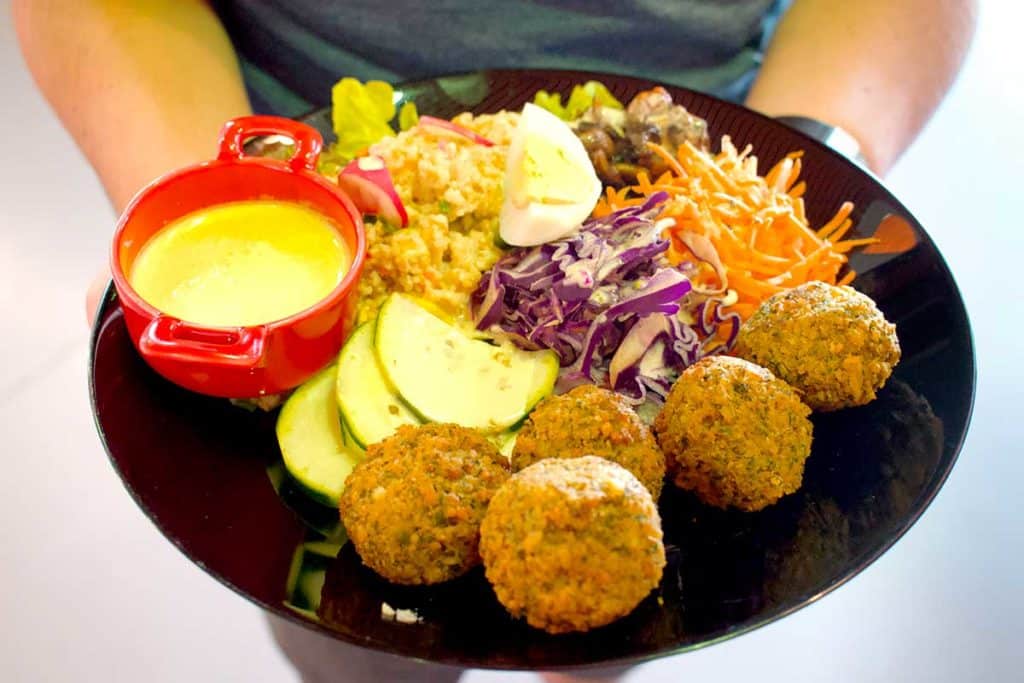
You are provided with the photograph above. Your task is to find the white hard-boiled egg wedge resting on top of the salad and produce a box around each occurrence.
[499,104,601,247]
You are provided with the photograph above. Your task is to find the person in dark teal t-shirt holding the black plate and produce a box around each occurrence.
[13,0,977,682]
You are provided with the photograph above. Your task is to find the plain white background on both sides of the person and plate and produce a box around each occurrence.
[0,0,1024,683]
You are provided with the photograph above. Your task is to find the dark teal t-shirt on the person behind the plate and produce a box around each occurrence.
[207,0,785,116]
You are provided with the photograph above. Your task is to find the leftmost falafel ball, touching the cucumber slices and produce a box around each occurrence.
[339,424,509,584]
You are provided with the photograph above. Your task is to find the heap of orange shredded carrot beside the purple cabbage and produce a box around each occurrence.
[594,136,878,319]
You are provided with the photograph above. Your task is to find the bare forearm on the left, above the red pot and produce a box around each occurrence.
[13,0,249,211]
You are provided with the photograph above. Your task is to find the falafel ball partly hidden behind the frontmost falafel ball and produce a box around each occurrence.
[512,384,665,501]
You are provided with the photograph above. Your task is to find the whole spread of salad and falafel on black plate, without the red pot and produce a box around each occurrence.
[268,79,899,633]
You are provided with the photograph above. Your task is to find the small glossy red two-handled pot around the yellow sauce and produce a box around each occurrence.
[111,116,367,398]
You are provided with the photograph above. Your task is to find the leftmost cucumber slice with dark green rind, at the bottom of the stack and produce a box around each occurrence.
[276,365,362,507]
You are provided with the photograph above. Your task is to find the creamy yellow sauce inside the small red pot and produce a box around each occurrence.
[128,201,351,327]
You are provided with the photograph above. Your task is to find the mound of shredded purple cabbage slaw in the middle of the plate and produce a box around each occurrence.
[470,193,739,403]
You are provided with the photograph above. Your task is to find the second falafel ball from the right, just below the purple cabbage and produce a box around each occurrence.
[654,355,811,511]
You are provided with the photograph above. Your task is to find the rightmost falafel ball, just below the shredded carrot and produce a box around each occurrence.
[735,282,900,411]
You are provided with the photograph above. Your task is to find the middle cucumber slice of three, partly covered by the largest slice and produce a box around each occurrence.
[336,322,420,449]
